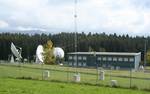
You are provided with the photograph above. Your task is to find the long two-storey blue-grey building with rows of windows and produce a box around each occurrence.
[67,52,141,69]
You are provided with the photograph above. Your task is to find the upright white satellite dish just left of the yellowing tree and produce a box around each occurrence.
[36,45,44,63]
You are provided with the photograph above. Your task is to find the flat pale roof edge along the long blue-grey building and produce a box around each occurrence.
[68,52,141,56]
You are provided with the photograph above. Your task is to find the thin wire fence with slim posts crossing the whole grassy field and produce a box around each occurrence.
[0,61,150,90]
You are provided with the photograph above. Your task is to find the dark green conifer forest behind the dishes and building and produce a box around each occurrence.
[0,32,150,63]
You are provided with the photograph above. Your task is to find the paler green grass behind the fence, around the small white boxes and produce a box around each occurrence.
[0,64,150,89]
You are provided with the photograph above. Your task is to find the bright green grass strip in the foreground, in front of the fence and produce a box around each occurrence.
[0,78,149,94]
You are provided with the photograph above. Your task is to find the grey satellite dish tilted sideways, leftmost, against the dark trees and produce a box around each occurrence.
[11,43,22,59]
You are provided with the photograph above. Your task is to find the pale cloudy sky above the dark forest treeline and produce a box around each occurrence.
[0,0,150,36]
